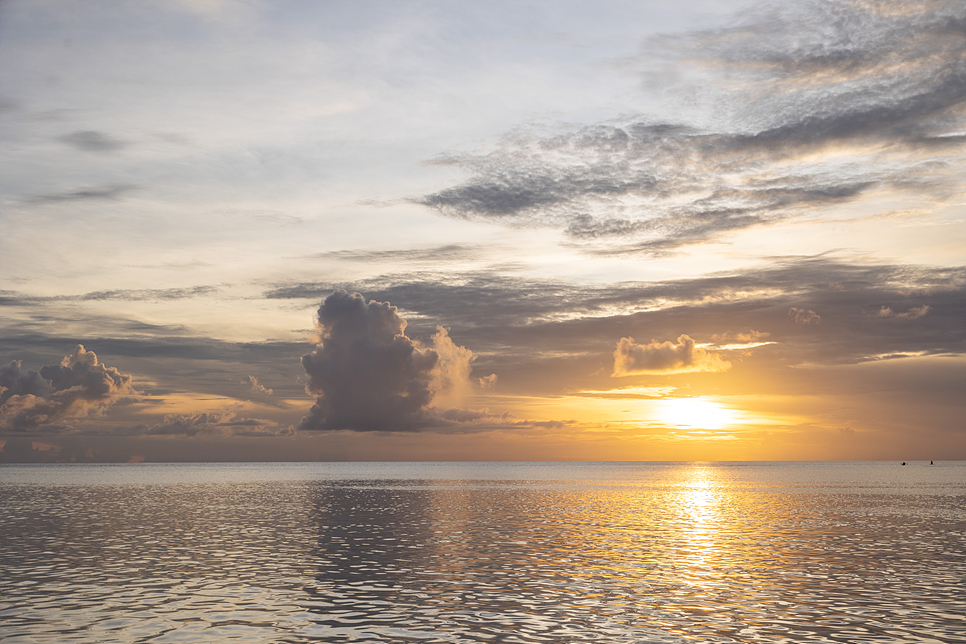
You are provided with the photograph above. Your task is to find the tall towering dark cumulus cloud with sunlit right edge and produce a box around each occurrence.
[300,290,492,431]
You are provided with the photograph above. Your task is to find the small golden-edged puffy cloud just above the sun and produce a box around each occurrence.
[613,335,731,376]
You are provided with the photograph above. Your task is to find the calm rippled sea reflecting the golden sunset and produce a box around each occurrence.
[0,463,966,644]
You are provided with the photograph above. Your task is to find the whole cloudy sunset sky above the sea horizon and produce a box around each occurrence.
[0,0,966,462]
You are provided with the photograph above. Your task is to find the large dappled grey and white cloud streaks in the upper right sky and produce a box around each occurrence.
[414,0,966,253]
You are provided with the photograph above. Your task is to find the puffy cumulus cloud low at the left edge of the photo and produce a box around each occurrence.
[0,344,137,430]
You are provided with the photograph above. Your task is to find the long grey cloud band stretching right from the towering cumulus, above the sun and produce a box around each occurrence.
[266,256,966,386]
